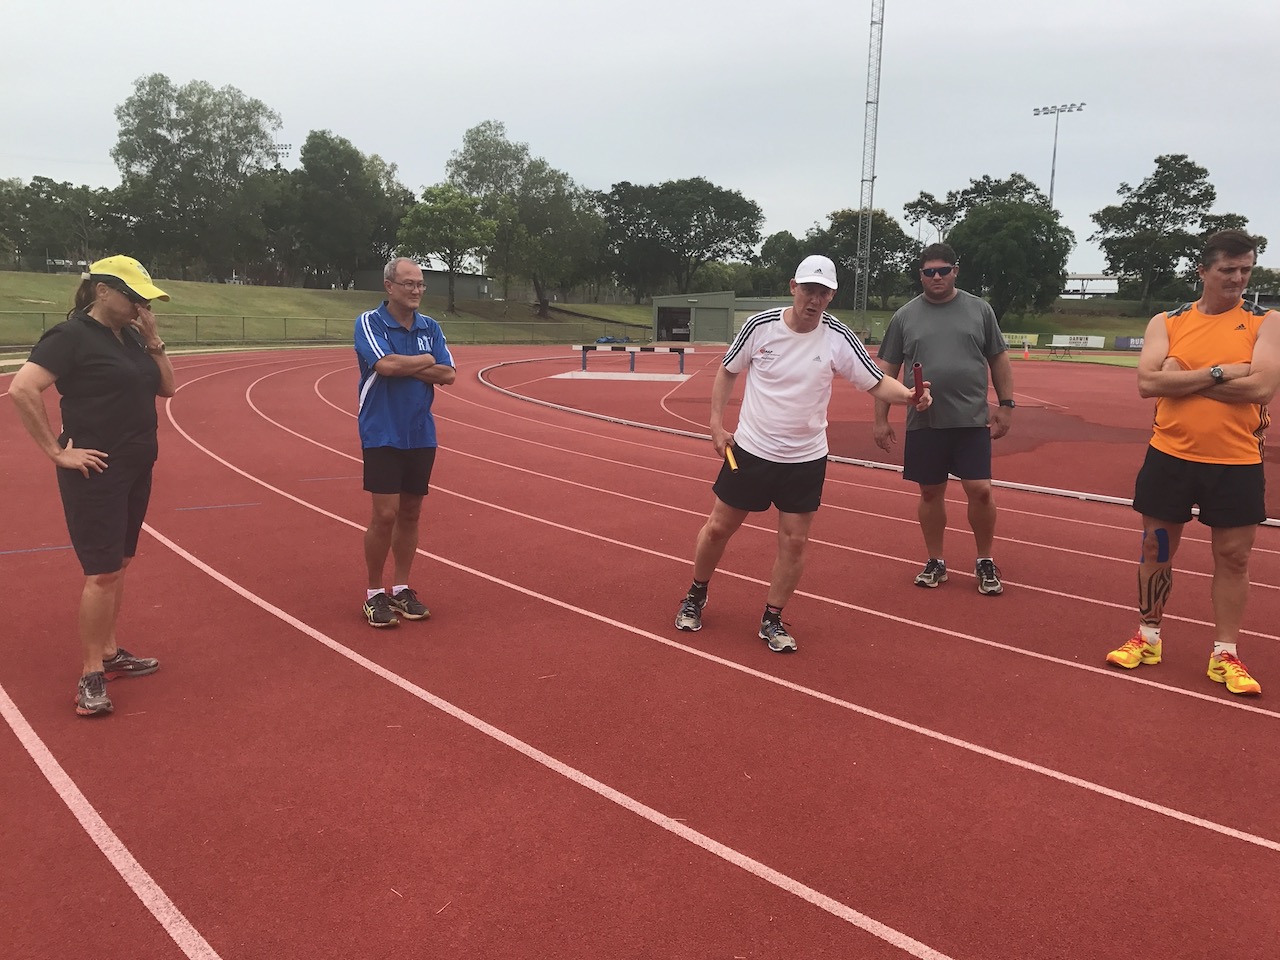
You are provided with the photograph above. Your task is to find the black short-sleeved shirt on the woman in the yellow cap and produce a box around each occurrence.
[28,311,160,460]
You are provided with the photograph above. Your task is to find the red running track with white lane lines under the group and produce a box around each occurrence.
[0,347,1280,960]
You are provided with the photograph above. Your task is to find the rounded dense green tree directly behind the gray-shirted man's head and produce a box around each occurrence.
[947,200,1075,321]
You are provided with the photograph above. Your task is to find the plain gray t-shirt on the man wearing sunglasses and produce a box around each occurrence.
[877,291,1007,430]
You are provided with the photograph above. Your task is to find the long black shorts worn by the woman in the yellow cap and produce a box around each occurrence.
[58,456,155,576]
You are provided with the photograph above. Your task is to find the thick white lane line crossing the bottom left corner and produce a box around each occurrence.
[0,686,221,960]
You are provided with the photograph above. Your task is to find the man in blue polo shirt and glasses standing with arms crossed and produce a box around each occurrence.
[356,257,457,627]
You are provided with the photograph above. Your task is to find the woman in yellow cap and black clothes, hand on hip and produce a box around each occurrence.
[9,256,175,717]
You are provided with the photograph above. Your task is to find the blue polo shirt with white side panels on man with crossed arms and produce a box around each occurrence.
[356,301,456,451]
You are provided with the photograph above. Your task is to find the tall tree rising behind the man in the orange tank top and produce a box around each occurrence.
[1089,154,1248,310]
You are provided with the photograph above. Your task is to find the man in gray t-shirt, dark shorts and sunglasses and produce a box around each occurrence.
[873,243,1014,596]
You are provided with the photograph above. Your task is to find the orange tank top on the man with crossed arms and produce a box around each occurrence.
[1151,301,1271,463]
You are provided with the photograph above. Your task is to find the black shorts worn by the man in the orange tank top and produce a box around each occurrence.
[1133,447,1267,527]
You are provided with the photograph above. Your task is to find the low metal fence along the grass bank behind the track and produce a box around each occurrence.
[0,311,650,351]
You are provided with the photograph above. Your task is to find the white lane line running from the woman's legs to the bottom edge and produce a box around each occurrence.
[145,527,950,960]
